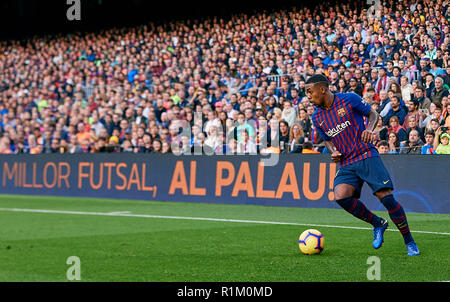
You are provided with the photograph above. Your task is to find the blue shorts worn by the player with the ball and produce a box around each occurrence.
[334,156,394,198]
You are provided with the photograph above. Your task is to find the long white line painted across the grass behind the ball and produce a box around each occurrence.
[0,208,450,236]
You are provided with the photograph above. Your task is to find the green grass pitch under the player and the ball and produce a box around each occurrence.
[0,195,450,281]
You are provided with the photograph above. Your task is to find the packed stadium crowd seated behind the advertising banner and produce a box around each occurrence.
[0,0,450,154]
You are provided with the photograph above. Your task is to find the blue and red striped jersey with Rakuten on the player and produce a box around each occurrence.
[312,92,379,167]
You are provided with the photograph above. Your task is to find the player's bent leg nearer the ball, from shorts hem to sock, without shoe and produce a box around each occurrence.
[334,165,384,227]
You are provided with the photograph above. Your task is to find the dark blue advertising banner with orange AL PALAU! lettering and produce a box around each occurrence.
[0,153,450,214]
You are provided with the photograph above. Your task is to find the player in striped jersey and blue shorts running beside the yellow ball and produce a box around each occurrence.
[306,74,420,256]
